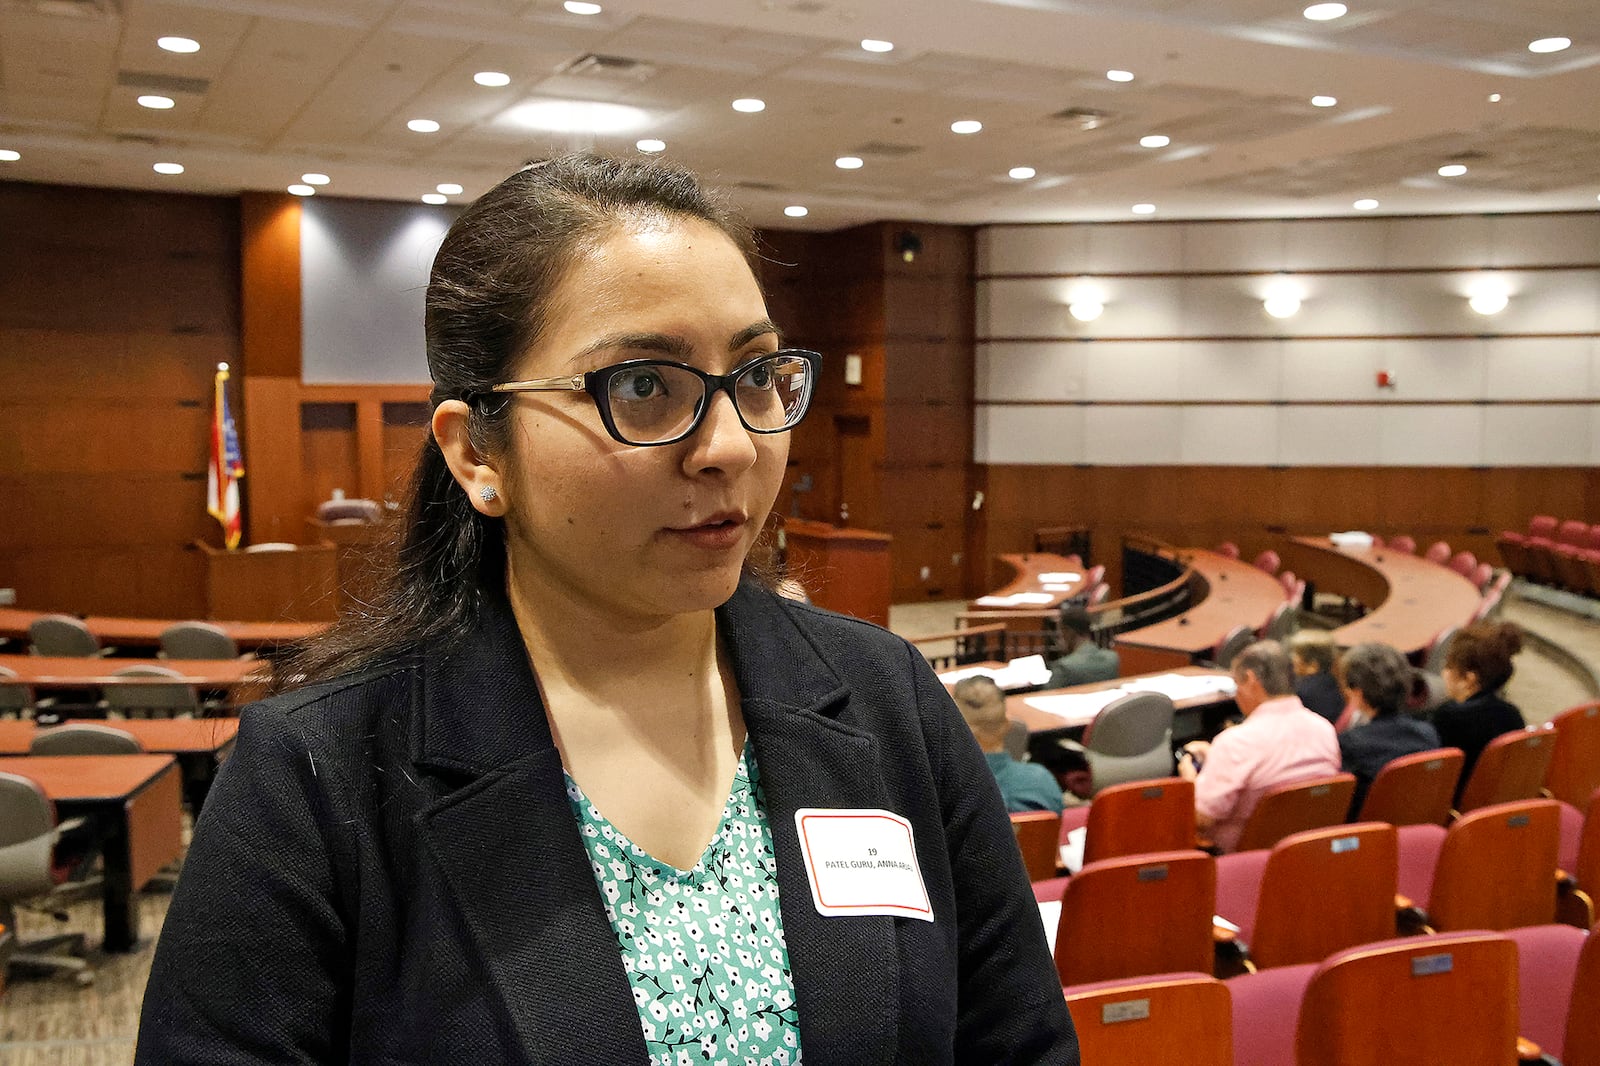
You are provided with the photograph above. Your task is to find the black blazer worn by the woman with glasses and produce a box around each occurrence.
[136,584,1078,1066]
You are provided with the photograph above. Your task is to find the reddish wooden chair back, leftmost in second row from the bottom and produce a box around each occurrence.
[1056,852,1216,986]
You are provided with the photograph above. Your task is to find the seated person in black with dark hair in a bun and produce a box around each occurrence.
[1434,623,1528,787]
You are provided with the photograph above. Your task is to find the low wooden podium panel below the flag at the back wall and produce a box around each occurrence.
[195,541,339,621]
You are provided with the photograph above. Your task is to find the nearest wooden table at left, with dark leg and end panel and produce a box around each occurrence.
[0,755,182,952]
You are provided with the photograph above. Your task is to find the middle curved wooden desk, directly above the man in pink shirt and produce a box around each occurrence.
[1115,547,1286,672]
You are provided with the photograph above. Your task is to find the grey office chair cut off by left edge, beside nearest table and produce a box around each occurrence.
[0,773,94,984]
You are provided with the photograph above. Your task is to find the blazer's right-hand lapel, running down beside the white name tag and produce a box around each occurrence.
[720,587,899,1064]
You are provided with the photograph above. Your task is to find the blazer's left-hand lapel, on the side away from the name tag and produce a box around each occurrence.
[411,589,646,1066]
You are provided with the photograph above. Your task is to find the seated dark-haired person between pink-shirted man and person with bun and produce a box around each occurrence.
[1339,643,1440,818]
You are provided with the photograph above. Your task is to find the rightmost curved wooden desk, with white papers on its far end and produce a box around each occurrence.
[1278,536,1480,655]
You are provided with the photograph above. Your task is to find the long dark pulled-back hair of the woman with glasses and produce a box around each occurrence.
[274,154,752,690]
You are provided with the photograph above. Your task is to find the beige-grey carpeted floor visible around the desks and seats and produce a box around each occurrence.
[0,585,1600,1066]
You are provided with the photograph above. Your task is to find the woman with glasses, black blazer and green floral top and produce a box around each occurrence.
[136,155,1077,1066]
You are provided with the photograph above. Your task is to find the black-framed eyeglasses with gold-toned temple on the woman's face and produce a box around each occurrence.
[490,347,822,447]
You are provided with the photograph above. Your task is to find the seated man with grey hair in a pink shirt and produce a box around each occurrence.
[1178,640,1339,852]
